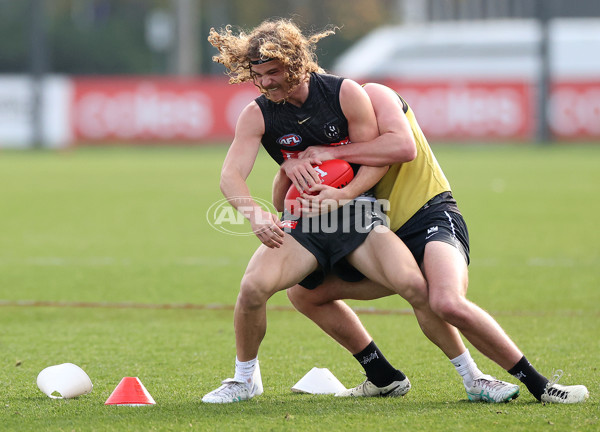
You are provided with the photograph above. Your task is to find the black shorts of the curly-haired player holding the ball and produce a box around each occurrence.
[282,199,386,289]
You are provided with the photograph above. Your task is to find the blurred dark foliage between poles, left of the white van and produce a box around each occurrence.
[0,0,398,75]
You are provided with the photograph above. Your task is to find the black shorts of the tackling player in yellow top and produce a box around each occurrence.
[330,192,470,282]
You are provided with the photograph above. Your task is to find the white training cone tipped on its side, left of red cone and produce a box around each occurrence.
[37,363,93,399]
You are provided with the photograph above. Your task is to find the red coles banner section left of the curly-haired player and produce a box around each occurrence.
[71,78,259,142]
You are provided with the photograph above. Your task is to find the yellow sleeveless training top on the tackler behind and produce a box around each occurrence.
[375,95,451,231]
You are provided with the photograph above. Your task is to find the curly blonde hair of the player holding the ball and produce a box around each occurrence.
[208,19,337,91]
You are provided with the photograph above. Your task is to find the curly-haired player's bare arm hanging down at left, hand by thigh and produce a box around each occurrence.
[220,102,283,247]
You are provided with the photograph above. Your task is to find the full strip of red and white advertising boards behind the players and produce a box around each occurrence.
[0,76,600,148]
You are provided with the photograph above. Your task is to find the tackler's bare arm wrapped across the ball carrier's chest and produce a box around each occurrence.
[300,84,417,166]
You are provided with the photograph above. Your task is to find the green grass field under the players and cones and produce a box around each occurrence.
[0,145,600,431]
